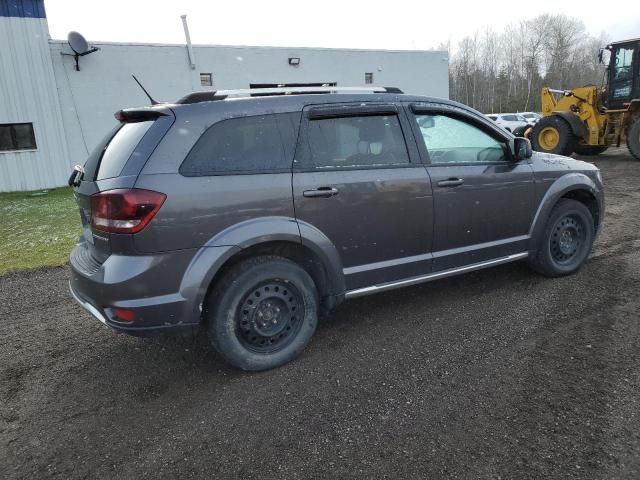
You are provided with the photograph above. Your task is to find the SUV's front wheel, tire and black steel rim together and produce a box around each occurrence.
[529,198,595,277]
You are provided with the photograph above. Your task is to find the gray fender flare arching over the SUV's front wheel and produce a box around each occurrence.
[529,172,604,256]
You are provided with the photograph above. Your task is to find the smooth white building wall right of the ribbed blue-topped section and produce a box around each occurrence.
[51,41,449,174]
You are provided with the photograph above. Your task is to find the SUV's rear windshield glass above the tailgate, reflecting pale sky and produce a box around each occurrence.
[96,121,153,180]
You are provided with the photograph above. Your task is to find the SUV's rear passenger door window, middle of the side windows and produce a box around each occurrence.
[305,115,409,168]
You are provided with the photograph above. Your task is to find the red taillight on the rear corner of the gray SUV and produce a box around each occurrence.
[91,188,167,233]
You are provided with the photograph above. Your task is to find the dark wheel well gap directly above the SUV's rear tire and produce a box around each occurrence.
[209,241,329,304]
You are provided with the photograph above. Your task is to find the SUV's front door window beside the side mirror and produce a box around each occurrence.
[416,115,506,163]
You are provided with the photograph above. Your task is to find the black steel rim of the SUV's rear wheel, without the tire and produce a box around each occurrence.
[236,279,304,354]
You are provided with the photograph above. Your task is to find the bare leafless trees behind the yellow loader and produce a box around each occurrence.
[444,14,607,113]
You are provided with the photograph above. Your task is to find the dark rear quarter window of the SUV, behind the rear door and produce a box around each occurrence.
[180,114,295,176]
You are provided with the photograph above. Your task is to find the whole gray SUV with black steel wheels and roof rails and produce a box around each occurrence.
[70,87,604,370]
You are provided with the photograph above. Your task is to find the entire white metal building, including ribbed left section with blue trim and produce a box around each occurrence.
[0,0,449,191]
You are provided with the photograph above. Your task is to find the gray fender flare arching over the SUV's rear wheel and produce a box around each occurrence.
[180,216,345,316]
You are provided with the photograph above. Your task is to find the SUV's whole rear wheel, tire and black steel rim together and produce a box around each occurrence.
[204,256,318,371]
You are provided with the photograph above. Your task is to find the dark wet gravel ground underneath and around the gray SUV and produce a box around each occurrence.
[0,150,640,479]
